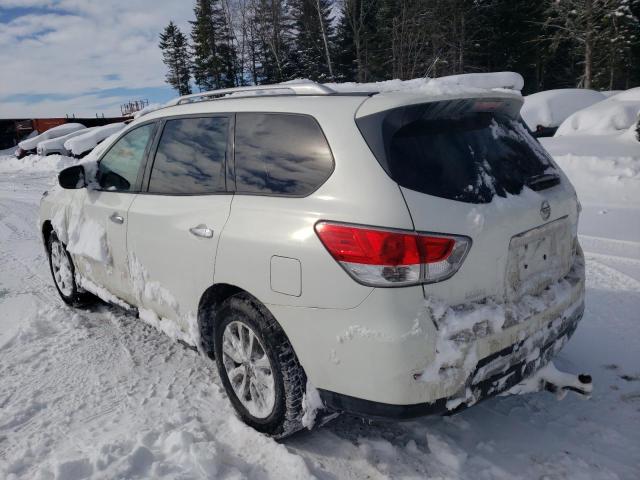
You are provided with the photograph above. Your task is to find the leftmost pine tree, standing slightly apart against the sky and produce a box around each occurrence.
[159,21,191,95]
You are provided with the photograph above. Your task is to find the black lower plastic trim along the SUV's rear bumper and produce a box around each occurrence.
[319,304,584,420]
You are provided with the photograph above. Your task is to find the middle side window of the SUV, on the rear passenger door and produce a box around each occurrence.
[149,117,229,195]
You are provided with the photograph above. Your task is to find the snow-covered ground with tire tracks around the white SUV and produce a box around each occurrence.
[0,144,640,480]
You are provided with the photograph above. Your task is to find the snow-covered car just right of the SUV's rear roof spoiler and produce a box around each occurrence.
[520,88,607,137]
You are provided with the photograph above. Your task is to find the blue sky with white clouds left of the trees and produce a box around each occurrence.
[0,0,193,118]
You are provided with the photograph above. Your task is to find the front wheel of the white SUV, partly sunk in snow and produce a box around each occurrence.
[47,232,93,307]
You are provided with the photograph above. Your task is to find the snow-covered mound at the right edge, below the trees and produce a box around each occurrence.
[555,87,640,137]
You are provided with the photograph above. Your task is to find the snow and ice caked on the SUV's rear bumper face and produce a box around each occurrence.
[415,249,584,409]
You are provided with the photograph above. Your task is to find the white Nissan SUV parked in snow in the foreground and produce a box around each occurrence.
[40,84,584,437]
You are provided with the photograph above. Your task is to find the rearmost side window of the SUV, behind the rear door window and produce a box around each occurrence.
[235,113,333,196]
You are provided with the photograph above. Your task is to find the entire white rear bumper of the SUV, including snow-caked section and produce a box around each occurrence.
[268,248,584,408]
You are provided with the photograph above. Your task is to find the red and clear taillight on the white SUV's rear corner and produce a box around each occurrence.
[315,222,471,287]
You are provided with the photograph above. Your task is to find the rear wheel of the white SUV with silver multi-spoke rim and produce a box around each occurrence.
[213,293,307,439]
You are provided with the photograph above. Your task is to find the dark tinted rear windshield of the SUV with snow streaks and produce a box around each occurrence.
[357,100,559,203]
